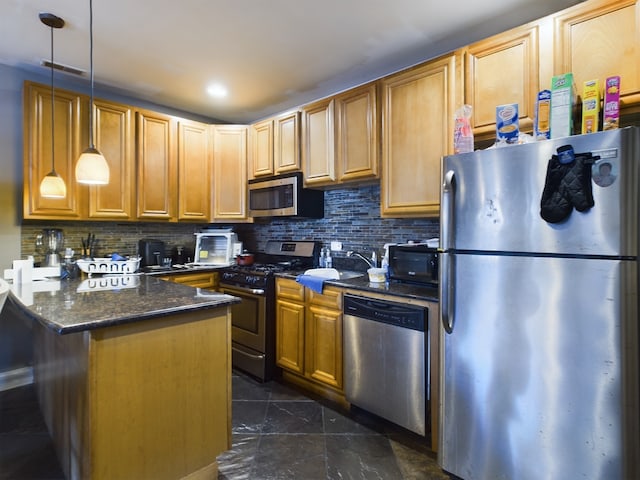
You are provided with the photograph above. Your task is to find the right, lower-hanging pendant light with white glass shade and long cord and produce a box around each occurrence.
[76,0,109,185]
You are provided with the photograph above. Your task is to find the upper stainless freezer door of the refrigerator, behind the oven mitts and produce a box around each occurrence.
[441,128,640,256]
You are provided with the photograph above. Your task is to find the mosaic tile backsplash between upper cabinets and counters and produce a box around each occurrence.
[21,185,439,268]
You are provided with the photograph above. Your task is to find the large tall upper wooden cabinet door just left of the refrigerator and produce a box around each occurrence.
[380,53,462,217]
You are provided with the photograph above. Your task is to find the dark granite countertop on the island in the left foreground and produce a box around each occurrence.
[10,275,240,334]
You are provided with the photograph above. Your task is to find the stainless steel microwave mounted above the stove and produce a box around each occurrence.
[249,172,324,218]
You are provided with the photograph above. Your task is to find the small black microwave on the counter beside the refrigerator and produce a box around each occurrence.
[389,243,438,286]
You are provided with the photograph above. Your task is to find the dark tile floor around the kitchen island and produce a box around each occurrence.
[0,373,449,480]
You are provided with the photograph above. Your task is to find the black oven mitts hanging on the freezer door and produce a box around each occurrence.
[540,145,600,223]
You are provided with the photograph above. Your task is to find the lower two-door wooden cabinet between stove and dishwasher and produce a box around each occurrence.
[276,278,344,400]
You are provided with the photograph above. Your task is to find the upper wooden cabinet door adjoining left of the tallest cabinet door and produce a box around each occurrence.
[335,83,380,182]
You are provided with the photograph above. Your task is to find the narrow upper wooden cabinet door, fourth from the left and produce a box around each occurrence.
[178,120,213,223]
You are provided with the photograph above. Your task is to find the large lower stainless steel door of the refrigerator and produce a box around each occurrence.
[439,255,640,480]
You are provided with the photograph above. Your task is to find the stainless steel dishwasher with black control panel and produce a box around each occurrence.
[343,294,429,436]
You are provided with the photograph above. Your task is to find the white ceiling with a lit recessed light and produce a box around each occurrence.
[0,0,581,123]
